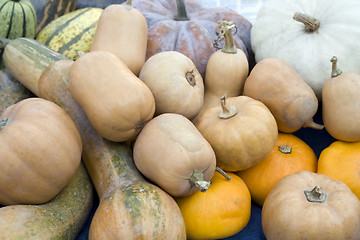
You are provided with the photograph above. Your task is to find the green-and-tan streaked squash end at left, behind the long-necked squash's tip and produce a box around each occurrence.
[0,37,66,95]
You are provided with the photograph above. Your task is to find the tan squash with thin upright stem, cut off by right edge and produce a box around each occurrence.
[322,56,360,142]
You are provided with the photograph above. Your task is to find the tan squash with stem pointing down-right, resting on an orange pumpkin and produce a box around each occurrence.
[133,113,216,197]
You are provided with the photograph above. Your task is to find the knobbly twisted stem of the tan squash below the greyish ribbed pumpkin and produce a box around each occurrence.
[213,21,238,53]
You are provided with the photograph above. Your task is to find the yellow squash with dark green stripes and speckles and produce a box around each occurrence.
[36,7,103,60]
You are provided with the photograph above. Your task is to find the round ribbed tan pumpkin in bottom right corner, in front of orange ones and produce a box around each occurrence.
[261,171,360,240]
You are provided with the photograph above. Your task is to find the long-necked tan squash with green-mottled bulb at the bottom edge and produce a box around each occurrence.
[39,60,186,240]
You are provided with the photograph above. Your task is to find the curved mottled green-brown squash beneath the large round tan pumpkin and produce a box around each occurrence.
[0,164,94,240]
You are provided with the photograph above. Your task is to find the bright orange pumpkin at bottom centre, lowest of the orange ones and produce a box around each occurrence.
[175,171,251,239]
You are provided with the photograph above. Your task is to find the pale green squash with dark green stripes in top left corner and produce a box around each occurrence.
[0,0,37,39]
